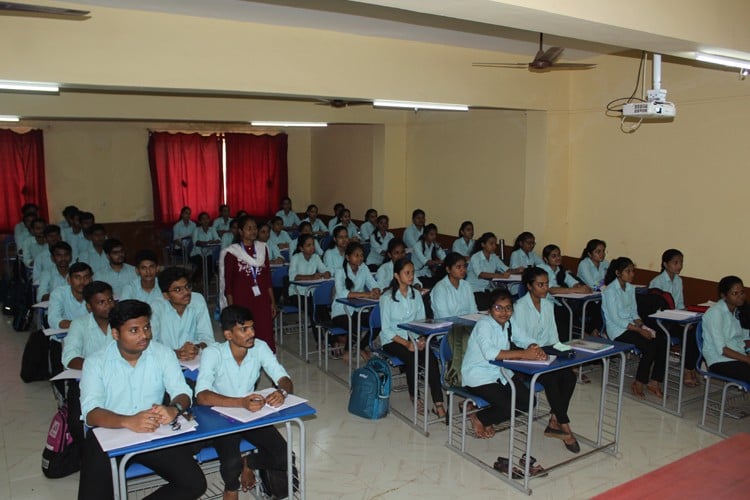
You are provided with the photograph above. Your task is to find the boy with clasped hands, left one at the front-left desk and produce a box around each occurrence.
[78,300,206,500]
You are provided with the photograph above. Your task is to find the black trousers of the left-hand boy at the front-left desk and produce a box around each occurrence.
[78,431,206,500]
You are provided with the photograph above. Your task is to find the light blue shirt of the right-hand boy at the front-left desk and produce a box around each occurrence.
[195,337,289,398]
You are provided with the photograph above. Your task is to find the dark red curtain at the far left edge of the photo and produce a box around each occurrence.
[0,130,48,233]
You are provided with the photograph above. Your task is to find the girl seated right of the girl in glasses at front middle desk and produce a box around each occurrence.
[511,267,581,453]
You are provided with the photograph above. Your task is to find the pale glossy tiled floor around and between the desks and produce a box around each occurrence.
[0,318,750,500]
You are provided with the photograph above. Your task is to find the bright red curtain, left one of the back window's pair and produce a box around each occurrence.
[148,132,222,223]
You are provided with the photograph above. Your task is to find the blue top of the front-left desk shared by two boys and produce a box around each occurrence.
[107,403,315,458]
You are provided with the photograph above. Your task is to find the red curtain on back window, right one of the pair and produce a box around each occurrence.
[225,134,287,218]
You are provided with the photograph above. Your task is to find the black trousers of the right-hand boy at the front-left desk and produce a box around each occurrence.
[214,426,287,491]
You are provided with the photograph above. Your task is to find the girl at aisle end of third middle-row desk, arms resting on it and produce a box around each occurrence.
[331,241,380,361]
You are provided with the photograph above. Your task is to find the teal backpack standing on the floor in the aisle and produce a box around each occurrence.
[349,358,391,420]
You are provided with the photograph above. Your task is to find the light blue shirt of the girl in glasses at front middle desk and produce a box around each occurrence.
[461,316,513,387]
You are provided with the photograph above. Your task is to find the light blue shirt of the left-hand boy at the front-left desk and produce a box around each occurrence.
[81,341,192,421]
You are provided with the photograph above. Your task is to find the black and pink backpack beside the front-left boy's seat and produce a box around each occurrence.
[42,403,81,479]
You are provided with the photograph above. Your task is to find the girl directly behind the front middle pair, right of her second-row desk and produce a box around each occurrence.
[430,252,477,318]
